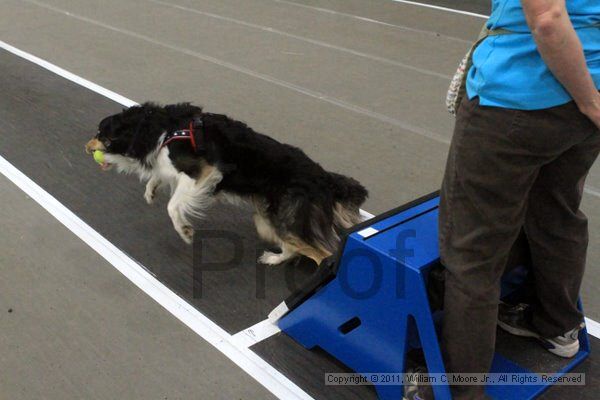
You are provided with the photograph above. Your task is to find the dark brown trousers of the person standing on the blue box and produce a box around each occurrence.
[439,98,600,400]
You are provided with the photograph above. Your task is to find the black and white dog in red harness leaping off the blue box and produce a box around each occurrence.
[86,103,367,265]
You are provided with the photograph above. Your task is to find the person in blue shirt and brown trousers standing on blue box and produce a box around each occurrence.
[436,0,600,400]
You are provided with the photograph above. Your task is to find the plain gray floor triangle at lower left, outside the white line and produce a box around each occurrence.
[0,175,274,400]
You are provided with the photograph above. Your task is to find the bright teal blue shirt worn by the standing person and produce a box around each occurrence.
[467,0,600,110]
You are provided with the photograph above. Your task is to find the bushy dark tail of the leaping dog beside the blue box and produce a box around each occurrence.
[330,173,369,231]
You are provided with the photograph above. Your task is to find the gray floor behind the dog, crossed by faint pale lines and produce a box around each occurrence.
[0,0,600,396]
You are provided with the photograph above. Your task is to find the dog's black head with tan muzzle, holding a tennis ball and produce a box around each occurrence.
[85,103,163,170]
